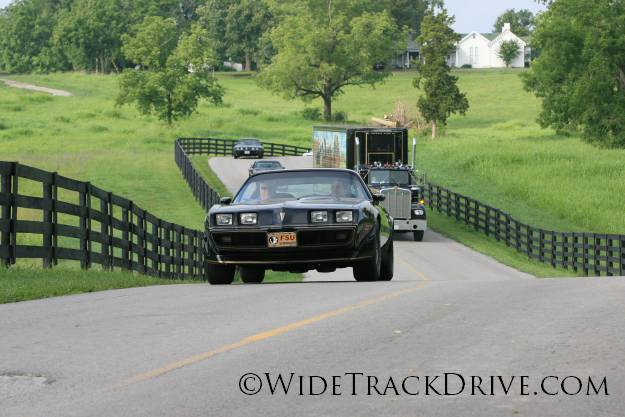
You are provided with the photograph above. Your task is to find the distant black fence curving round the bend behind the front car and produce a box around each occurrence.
[174,138,310,211]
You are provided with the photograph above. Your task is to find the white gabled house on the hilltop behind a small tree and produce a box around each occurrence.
[449,23,531,68]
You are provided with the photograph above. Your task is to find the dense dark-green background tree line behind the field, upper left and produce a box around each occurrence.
[0,0,427,73]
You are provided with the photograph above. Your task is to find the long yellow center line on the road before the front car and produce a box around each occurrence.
[113,282,425,389]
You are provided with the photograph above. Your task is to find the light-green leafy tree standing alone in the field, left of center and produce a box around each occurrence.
[117,16,224,125]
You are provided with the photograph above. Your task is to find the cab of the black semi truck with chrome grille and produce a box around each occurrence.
[359,163,427,241]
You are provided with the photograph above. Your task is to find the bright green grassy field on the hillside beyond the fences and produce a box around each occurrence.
[0,70,625,294]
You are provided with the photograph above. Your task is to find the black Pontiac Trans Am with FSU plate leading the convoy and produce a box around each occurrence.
[204,169,393,284]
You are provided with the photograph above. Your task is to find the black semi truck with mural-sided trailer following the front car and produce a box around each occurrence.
[313,126,427,241]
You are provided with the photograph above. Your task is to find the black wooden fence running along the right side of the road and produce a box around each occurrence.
[425,183,625,276]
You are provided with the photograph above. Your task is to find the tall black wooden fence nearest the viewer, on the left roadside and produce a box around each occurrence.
[0,162,205,279]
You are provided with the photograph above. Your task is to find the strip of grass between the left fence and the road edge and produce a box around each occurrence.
[0,267,198,304]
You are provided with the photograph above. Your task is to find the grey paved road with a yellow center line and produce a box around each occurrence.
[0,157,625,417]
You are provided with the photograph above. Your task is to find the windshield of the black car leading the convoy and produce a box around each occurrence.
[233,171,369,204]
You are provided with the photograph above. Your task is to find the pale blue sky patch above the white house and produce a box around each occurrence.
[0,0,544,33]
